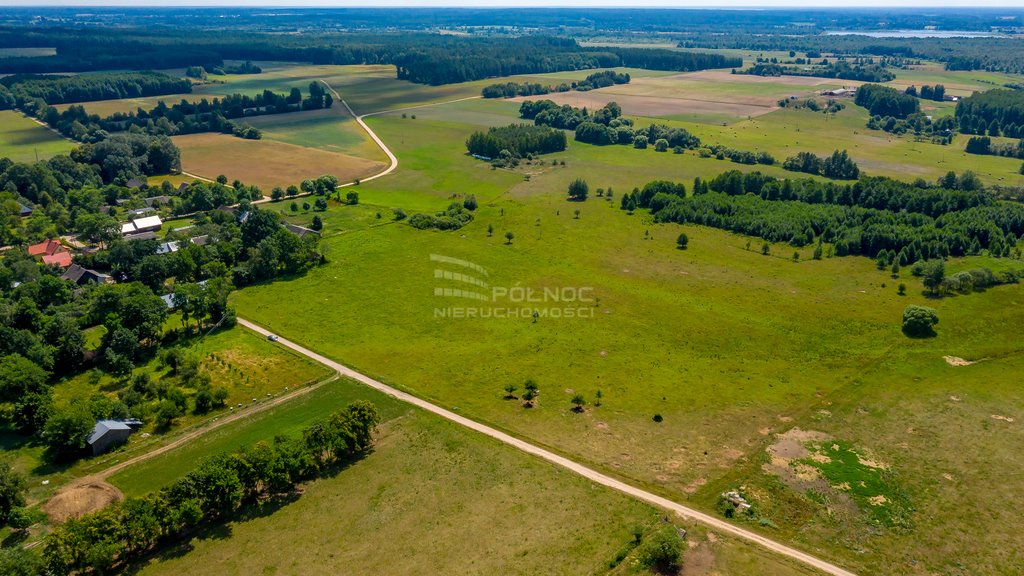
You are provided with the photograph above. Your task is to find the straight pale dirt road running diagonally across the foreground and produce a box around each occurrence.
[239,318,855,576]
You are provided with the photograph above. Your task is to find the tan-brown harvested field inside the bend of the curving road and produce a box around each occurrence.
[173,134,384,191]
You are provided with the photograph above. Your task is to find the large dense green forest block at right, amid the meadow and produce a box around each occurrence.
[622,171,1024,265]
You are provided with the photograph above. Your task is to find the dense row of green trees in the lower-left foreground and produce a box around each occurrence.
[38,401,381,575]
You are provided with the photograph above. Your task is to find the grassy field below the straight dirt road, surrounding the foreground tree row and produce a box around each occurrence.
[112,380,812,576]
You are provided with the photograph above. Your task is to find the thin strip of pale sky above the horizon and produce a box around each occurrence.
[12,0,1024,9]
